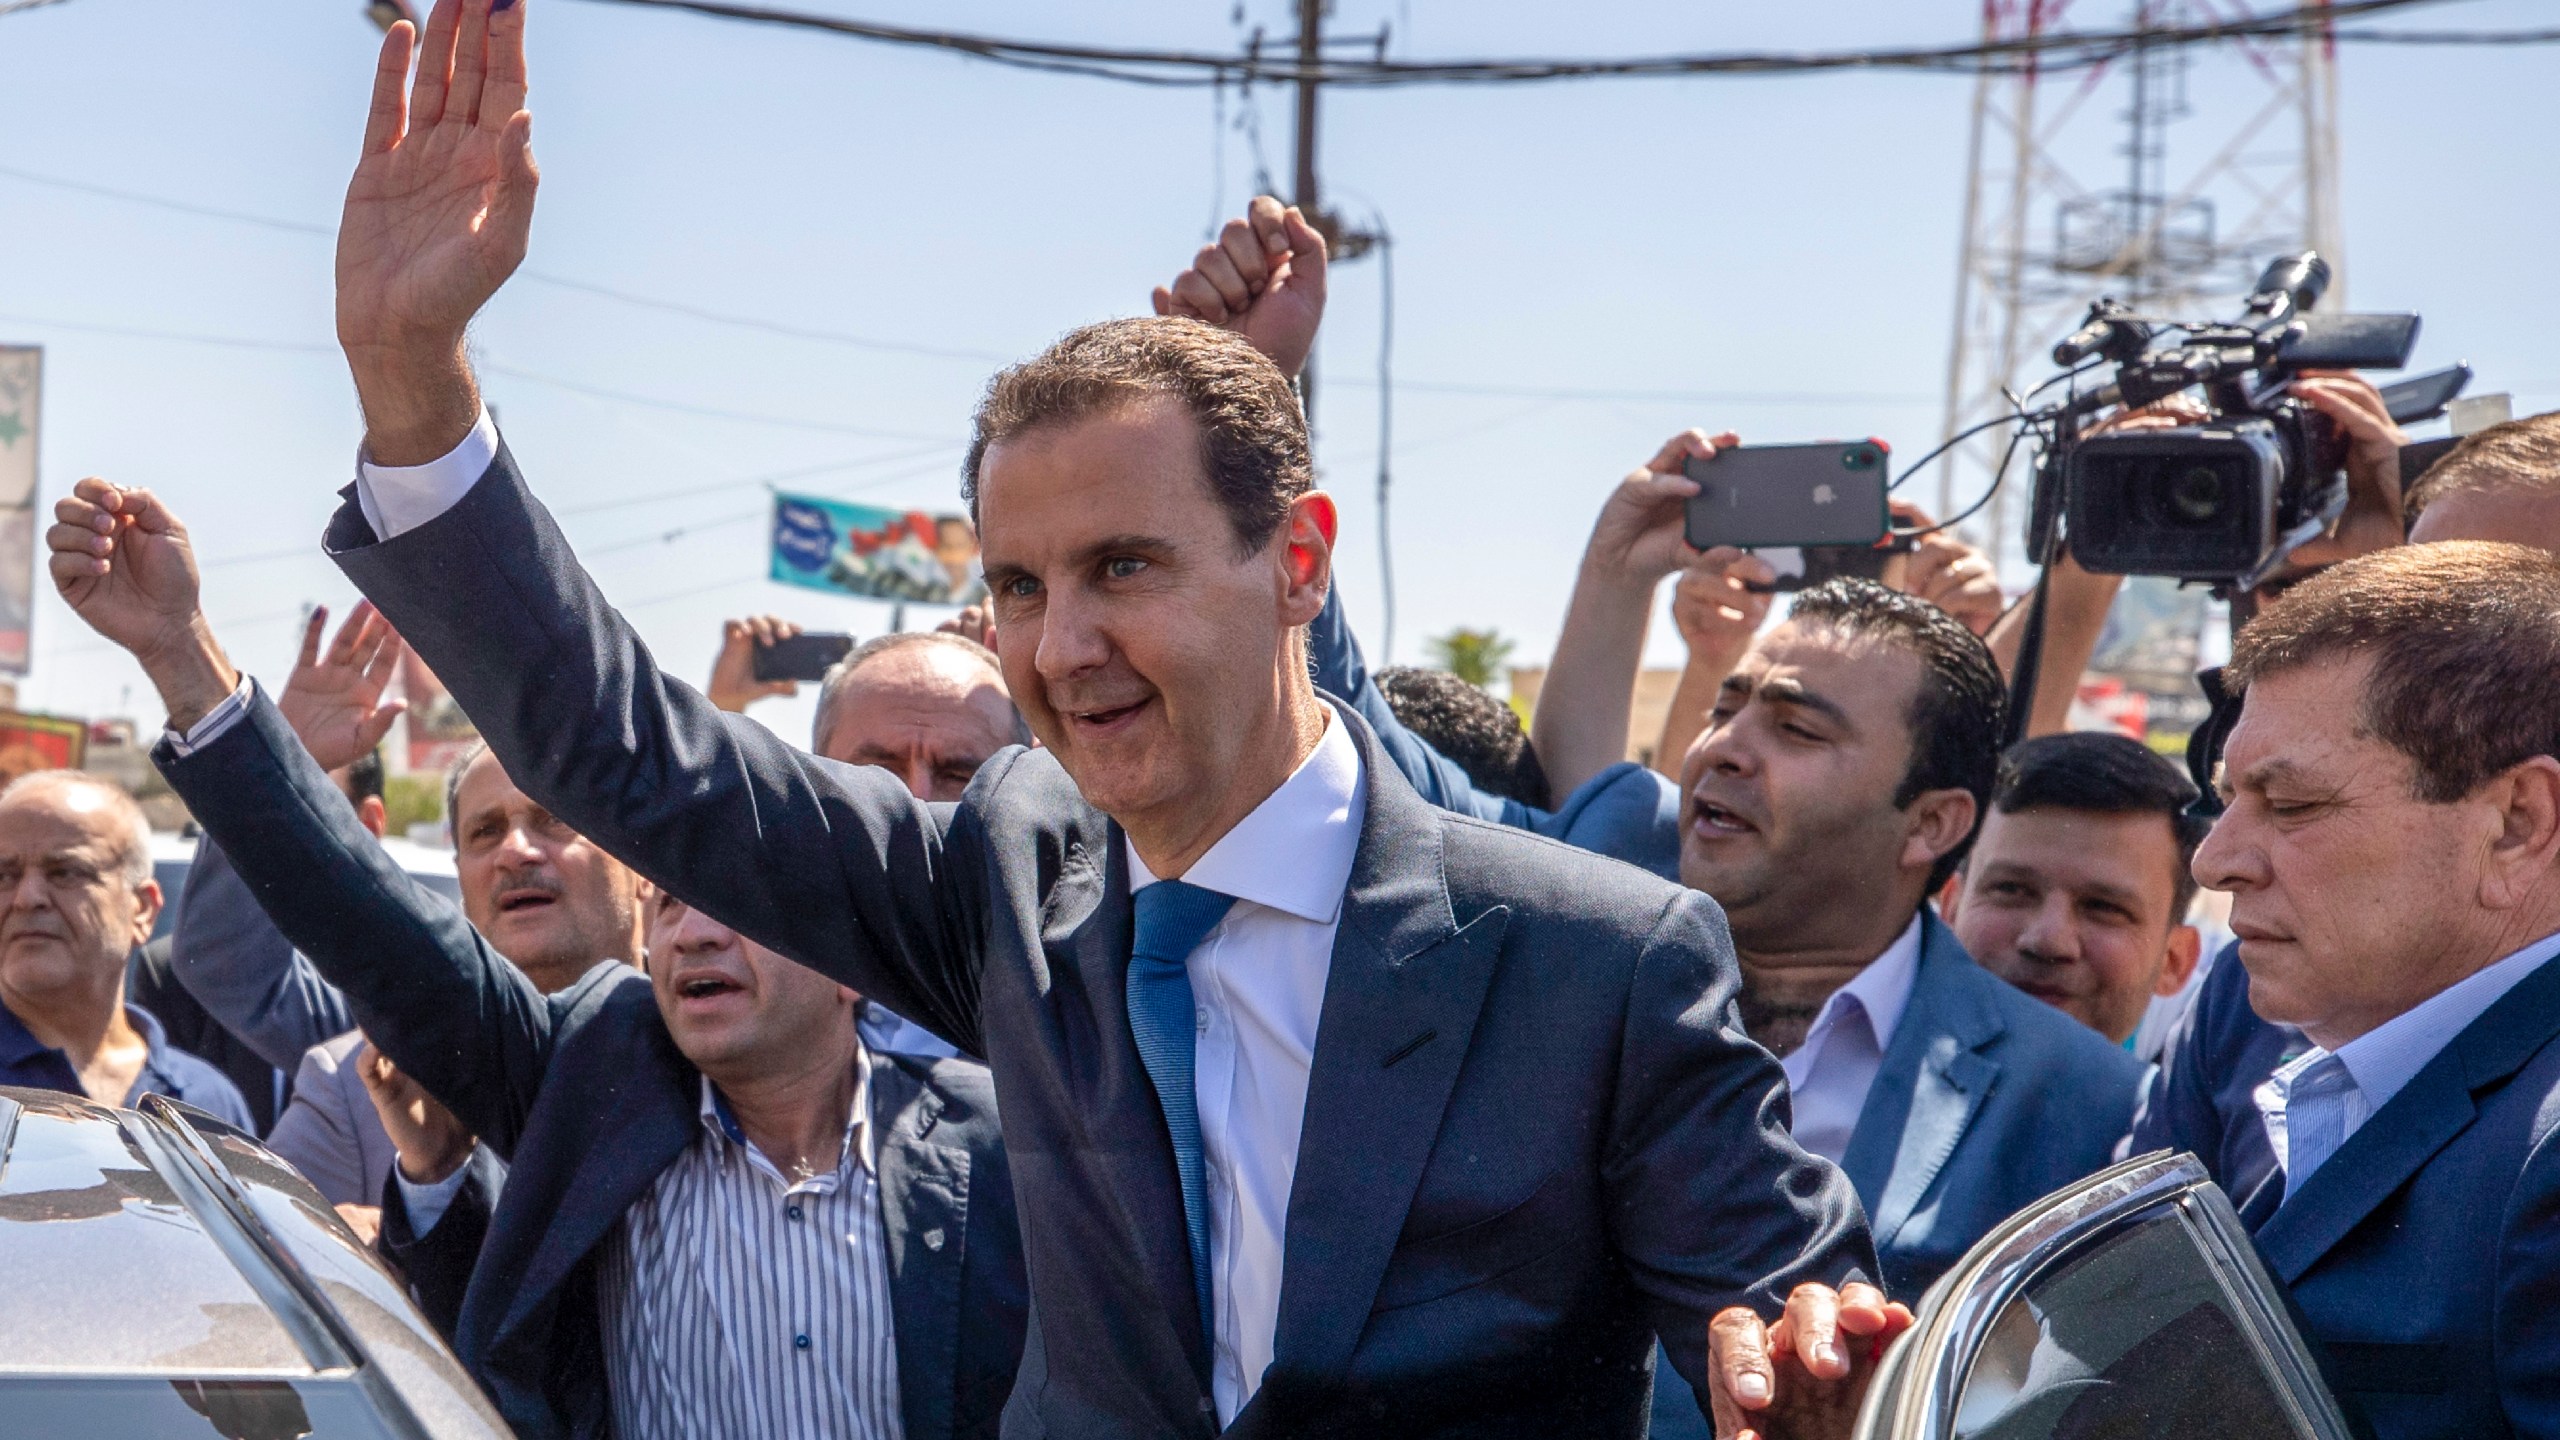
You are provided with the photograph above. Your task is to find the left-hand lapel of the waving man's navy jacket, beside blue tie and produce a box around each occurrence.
[1039,840,1208,1389]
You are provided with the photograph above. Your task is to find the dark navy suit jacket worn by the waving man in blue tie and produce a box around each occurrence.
[328,443,1874,1437]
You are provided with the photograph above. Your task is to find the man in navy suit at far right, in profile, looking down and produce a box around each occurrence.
[2181,543,2560,1440]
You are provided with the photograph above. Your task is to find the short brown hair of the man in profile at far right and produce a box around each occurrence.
[2222,541,2560,805]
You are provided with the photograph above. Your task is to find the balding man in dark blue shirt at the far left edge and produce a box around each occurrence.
[0,771,251,1130]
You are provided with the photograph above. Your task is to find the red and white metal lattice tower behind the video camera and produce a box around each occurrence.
[1935,0,2345,574]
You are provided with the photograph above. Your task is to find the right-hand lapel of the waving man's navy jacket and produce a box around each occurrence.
[1265,715,1510,1391]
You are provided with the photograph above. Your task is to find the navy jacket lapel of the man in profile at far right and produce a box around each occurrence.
[2258,961,2560,1284]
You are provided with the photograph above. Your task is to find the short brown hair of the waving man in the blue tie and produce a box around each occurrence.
[960,315,1316,553]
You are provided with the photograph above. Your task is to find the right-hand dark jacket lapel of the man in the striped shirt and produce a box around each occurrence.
[870,1053,968,1440]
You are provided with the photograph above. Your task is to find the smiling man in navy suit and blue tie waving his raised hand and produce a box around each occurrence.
[110,3,1907,1435]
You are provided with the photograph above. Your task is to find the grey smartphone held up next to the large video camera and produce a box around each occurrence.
[1684,441,1892,551]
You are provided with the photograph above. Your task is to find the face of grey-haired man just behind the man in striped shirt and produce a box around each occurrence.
[453,753,640,994]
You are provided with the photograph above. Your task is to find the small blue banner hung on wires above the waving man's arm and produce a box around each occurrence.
[765,492,986,605]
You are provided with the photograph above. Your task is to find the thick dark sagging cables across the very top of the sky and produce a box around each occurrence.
[565,0,2498,90]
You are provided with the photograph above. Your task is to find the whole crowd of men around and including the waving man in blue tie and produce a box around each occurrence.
[15,0,2560,1440]
